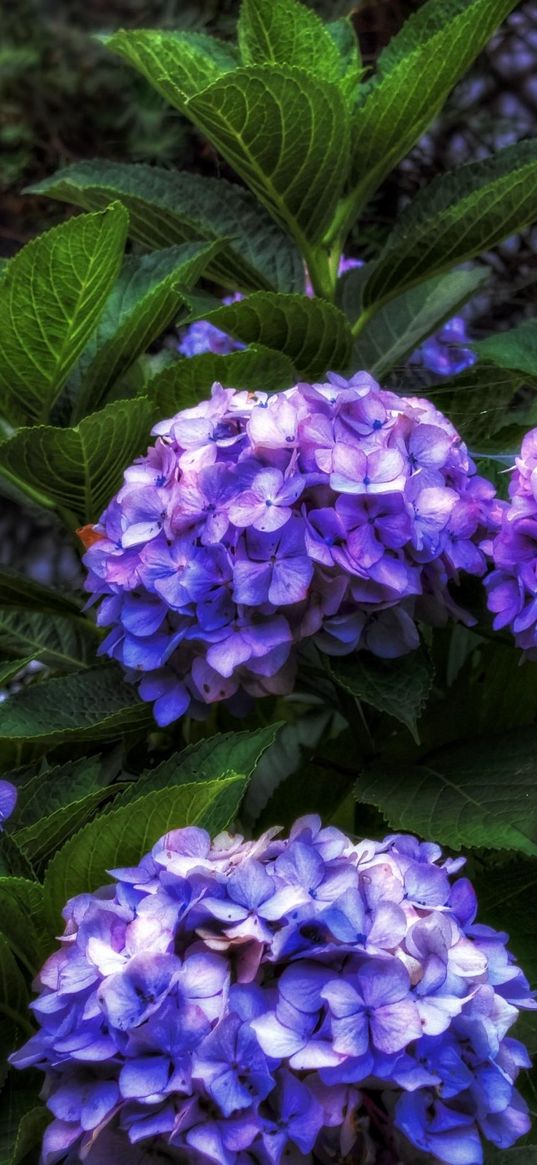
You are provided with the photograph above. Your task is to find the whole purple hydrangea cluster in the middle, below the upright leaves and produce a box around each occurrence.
[85,373,496,725]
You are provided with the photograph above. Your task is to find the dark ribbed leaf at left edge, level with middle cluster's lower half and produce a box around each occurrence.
[0,607,99,671]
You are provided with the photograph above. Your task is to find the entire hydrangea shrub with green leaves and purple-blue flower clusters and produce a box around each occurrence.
[0,0,537,1165]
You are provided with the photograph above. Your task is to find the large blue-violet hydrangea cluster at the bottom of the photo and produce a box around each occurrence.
[12,817,535,1165]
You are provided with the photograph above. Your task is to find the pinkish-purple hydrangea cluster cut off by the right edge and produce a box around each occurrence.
[486,429,537,659]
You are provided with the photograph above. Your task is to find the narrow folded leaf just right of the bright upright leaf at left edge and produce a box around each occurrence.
[69,242,225,422]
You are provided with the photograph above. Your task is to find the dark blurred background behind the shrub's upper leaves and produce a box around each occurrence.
[0,0,537,583]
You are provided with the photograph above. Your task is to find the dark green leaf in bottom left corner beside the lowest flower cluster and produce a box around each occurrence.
[0,1076,45,1165]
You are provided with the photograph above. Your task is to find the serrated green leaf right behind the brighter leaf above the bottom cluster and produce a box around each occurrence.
[118,723,281,805]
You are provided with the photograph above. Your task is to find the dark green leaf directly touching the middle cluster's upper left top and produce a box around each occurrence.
[146,345,298,417]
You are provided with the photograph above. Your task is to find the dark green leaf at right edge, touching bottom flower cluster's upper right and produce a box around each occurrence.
[473,857,537,982]
